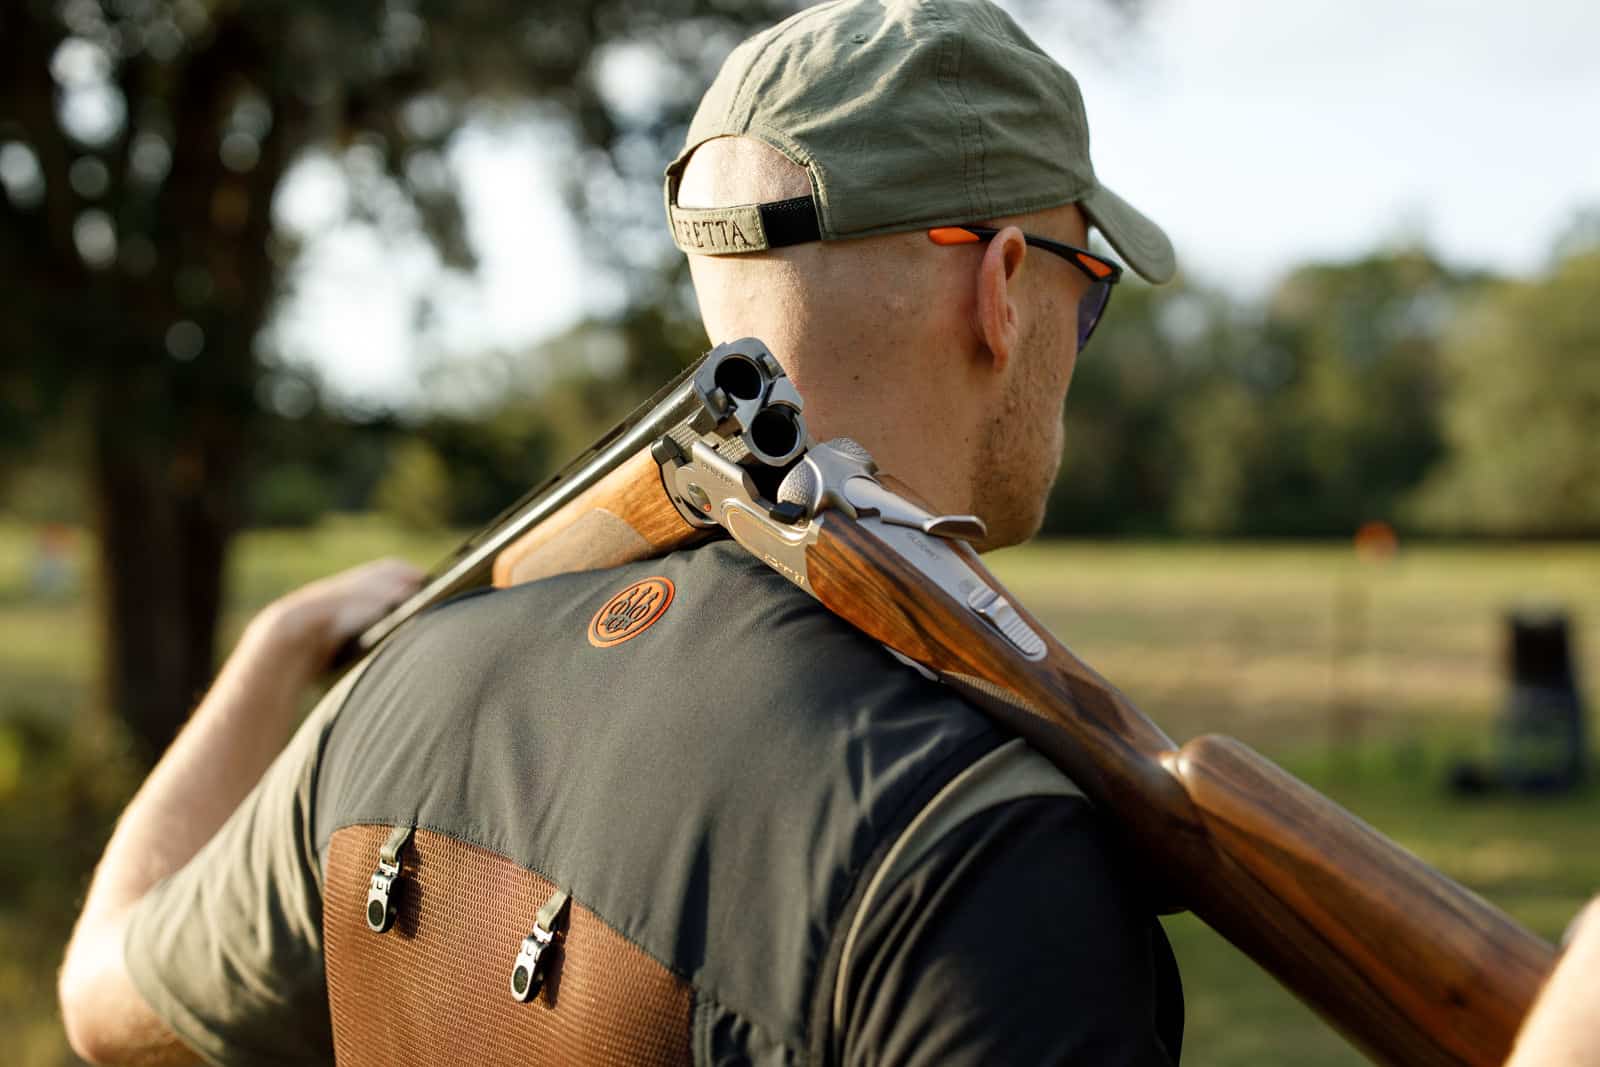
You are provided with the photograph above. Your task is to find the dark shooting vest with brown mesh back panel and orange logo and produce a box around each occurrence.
[314,542,1075,1067]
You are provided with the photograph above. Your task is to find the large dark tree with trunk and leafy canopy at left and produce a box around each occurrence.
[0,0,790,755]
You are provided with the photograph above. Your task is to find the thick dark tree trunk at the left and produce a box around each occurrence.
[77,18,288,760]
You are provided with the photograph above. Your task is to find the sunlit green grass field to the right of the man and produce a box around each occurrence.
[994,544,1600,1067]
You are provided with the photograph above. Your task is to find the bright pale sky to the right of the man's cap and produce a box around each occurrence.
[1029,0,1600,294]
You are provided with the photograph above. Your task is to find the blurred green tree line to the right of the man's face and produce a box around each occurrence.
[1046,230,1600,537]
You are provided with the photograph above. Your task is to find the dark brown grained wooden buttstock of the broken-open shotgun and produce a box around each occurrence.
[806,515,1554,1065]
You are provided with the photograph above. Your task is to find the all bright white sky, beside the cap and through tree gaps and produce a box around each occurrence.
[275,0,1600,405]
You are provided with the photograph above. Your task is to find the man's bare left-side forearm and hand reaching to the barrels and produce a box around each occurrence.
[59,560,421,1064]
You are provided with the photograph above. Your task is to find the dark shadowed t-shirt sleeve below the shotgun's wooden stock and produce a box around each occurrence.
[835,797,1182,1067]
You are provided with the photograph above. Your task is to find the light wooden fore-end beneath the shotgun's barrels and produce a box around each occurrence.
[494,448,704,589]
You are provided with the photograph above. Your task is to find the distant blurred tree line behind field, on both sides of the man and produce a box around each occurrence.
[6,230,1600,537]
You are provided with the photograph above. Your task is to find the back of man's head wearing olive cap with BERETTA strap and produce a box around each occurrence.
[666,0,1173,547]
